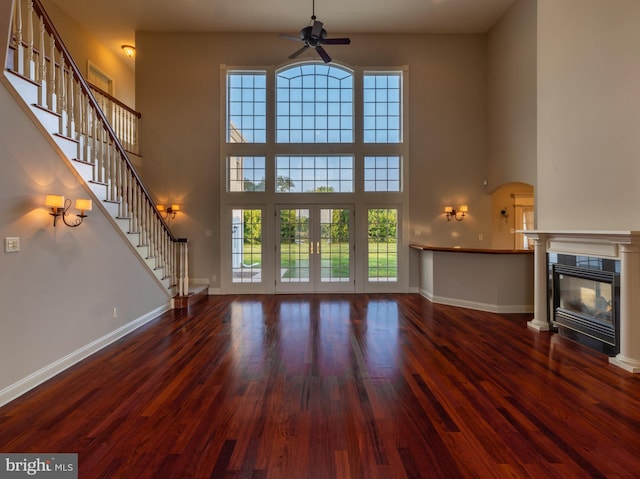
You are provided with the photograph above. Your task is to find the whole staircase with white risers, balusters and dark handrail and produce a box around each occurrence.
[0,0,189,307]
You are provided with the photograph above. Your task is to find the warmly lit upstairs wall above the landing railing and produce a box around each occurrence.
[42,0,136,108]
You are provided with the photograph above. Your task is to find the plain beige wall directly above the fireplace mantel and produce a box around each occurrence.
[536,0,640,230]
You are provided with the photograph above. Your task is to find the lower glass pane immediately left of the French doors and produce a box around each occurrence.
[231,209,262,283]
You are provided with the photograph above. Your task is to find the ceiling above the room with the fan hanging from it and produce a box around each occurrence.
[45,0,515,57]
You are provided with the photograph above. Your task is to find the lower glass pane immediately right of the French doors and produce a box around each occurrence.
[367,208,398,282]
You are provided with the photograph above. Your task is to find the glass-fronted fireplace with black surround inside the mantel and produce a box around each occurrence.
[547,253,620,356]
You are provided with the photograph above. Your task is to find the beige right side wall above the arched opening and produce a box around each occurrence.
[487,0,537,191]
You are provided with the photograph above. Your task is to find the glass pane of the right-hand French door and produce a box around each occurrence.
[319,208,351,283]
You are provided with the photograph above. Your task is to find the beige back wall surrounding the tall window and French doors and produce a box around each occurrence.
[136,32,491,287]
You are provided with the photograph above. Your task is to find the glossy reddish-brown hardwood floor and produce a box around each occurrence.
[0,295,640,479]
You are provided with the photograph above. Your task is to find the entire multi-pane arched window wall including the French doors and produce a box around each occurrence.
[220,61,408,291]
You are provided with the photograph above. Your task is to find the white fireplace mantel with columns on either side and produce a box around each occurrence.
[519,230,640,373]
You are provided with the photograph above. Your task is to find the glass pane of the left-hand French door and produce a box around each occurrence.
[280,208,312,283]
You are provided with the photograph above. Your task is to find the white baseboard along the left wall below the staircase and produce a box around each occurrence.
[0,303,171,406]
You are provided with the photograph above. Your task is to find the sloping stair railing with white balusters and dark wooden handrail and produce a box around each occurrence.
[6,0,189,296]
